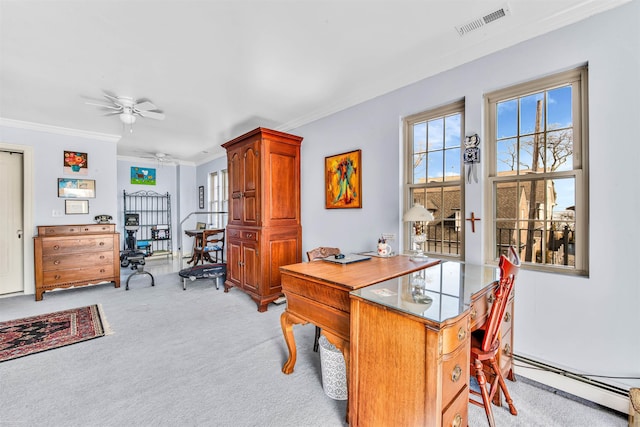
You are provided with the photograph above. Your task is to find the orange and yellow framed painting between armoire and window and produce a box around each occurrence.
[324,150,362,209]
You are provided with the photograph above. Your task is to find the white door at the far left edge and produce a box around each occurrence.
[0,151,24,295]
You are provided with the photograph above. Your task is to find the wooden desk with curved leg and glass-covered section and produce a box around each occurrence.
[280,256,498,426]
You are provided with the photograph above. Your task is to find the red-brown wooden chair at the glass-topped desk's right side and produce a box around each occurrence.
[469,247,520,427]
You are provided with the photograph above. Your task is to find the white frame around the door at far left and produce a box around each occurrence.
[0,142,36,294]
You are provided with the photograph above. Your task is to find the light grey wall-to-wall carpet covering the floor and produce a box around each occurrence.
[0,260,626,427]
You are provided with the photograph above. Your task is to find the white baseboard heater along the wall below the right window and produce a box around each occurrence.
[514,356,629,414]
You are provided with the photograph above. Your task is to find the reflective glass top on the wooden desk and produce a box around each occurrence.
[351,261,500,322]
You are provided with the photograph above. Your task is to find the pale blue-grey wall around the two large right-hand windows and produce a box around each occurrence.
[290,1,640,387]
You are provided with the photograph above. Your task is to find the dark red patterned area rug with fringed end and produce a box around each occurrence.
[0,305,108,362]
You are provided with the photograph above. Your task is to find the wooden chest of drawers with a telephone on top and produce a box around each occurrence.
[34,224,120,301]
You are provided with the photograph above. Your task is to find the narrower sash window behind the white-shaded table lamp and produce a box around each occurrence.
[404,100,464,258]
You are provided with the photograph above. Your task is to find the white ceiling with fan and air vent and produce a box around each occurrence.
[0,0,630,164]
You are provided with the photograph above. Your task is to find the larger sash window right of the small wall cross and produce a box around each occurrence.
[485,66,588,274]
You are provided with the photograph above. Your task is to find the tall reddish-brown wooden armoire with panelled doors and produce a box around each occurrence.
[222,128,302,312]
